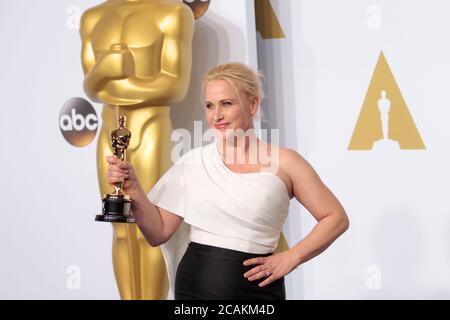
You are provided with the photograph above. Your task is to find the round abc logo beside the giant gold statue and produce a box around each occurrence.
[59,98,98,147]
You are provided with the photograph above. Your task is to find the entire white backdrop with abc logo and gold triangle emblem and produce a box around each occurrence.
[0,0,450,299]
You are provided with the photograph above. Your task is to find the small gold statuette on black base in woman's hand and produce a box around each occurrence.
[95,115,135,223]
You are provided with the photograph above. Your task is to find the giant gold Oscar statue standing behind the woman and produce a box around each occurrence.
[80,0,194,299]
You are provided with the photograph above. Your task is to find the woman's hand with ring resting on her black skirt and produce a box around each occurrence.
[244,250,298,287]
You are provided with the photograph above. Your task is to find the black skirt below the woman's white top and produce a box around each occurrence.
[175,242,286,300]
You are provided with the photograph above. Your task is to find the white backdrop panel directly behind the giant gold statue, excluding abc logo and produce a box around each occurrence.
[0,0,257,299]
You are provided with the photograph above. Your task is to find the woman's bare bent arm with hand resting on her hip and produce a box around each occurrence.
[244,149,349,287]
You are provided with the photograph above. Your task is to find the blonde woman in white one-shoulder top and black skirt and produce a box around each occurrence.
[107,63,349,299]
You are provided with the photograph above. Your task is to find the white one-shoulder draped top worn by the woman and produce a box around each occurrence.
[148,142,290,298]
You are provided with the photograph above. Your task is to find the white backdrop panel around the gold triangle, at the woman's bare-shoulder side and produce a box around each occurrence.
[258,0,450,299]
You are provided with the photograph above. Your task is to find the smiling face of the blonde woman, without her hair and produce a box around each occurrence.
[205,80,259,133]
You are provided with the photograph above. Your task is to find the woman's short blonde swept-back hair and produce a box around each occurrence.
[202,62,265,101]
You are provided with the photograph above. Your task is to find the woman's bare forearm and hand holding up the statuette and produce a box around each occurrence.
[107,156,183,247]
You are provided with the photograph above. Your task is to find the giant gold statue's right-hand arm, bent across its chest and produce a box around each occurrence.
[98,4,194,106]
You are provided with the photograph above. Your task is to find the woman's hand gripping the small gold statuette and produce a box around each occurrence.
[106,156,140,197]
